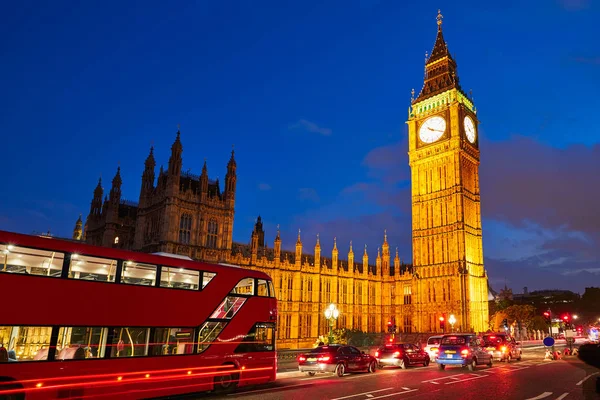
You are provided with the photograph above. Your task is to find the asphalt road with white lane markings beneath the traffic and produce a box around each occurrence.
[197,349,600,400]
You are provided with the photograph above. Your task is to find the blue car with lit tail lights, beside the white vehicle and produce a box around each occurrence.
[436,333,493,371]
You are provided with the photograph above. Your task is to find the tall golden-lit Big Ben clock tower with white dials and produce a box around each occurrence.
[407,11,488,332]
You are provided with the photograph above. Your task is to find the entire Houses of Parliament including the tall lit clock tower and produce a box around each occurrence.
[73,13,488,348]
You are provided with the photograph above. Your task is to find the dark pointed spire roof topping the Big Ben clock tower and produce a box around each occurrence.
[412,10,466,104]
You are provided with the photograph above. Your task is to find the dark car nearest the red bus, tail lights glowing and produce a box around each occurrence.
[298,344,377,377]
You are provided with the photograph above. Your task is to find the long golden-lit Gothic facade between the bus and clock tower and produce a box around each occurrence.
[230,217,414,348]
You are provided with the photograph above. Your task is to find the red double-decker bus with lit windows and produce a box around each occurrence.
[0,231,277,400]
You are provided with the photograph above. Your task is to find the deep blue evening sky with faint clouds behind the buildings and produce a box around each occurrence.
[0,0,600,292]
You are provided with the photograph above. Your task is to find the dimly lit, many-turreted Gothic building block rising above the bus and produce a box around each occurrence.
[82,131,237,262]
